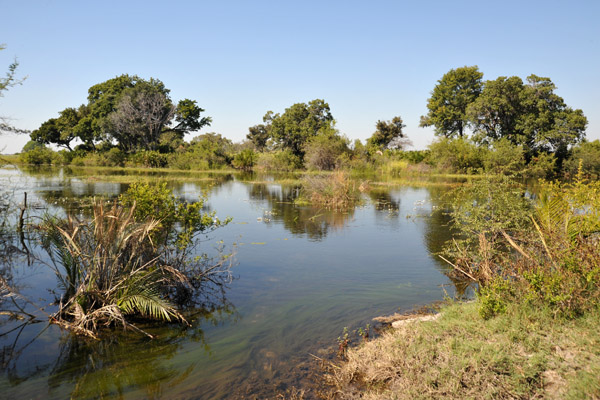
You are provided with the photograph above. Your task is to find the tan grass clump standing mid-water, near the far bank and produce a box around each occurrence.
[296,171,368,209]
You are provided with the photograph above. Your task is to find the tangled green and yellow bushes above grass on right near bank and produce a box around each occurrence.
[442,170,600,318]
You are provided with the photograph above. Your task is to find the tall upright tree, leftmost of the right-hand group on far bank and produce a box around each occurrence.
[419,65,483,137]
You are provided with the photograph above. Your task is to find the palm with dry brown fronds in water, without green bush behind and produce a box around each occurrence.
[44,201,190,336]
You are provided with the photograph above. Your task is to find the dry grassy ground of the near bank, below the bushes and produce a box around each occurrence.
[326,302,600,399]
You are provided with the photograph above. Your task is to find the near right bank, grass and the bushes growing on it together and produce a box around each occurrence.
[327,170,600,399]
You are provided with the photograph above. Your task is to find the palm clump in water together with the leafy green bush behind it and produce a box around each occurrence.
[41,184,231,337]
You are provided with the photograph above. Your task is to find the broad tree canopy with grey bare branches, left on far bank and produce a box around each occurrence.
[31,74,211,151]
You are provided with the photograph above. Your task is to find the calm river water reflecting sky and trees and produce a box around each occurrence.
[0,165,453,399]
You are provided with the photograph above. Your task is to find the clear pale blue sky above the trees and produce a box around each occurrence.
[0,0,600,154]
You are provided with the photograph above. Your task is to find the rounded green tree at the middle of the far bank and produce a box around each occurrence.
[267,99,333,159]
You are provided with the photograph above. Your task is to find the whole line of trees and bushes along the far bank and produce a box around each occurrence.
[21,66,600,176]
